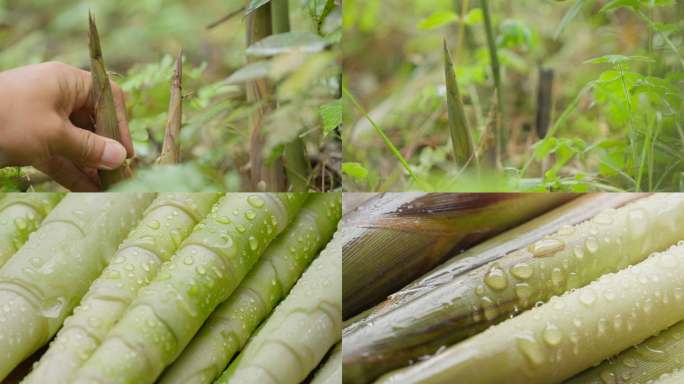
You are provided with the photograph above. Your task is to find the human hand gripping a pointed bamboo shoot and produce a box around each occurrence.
[0,62,133,191]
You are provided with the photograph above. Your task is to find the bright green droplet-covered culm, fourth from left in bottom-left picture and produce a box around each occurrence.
[73,193,308,384]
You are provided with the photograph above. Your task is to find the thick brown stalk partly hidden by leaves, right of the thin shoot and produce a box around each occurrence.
[246,2,286,191]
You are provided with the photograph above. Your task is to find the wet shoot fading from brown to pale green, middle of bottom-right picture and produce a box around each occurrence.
[344,194,684,383]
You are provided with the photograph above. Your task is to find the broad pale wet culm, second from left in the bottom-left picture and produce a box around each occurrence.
[0,193,154,380]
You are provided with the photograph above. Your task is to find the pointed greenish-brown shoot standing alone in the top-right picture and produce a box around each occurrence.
[444,40,478,168]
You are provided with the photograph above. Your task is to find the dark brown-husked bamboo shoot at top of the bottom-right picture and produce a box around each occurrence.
[341,193,576,319]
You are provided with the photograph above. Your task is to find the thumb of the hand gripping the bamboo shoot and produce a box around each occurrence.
[55,122,126,170]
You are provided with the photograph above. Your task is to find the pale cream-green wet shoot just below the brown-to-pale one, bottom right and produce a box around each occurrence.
[376,243,684,384]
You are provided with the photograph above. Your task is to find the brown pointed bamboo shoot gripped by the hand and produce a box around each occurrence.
[88,13,131,189]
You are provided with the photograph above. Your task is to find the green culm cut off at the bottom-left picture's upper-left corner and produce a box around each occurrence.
[0,193,64,267]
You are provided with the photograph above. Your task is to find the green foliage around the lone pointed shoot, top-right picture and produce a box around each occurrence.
[343,0,684,191]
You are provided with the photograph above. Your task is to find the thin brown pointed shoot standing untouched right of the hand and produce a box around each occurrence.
[157,49,183,164]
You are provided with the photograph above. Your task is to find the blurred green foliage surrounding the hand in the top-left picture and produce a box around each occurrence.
[0,0,341,191]
